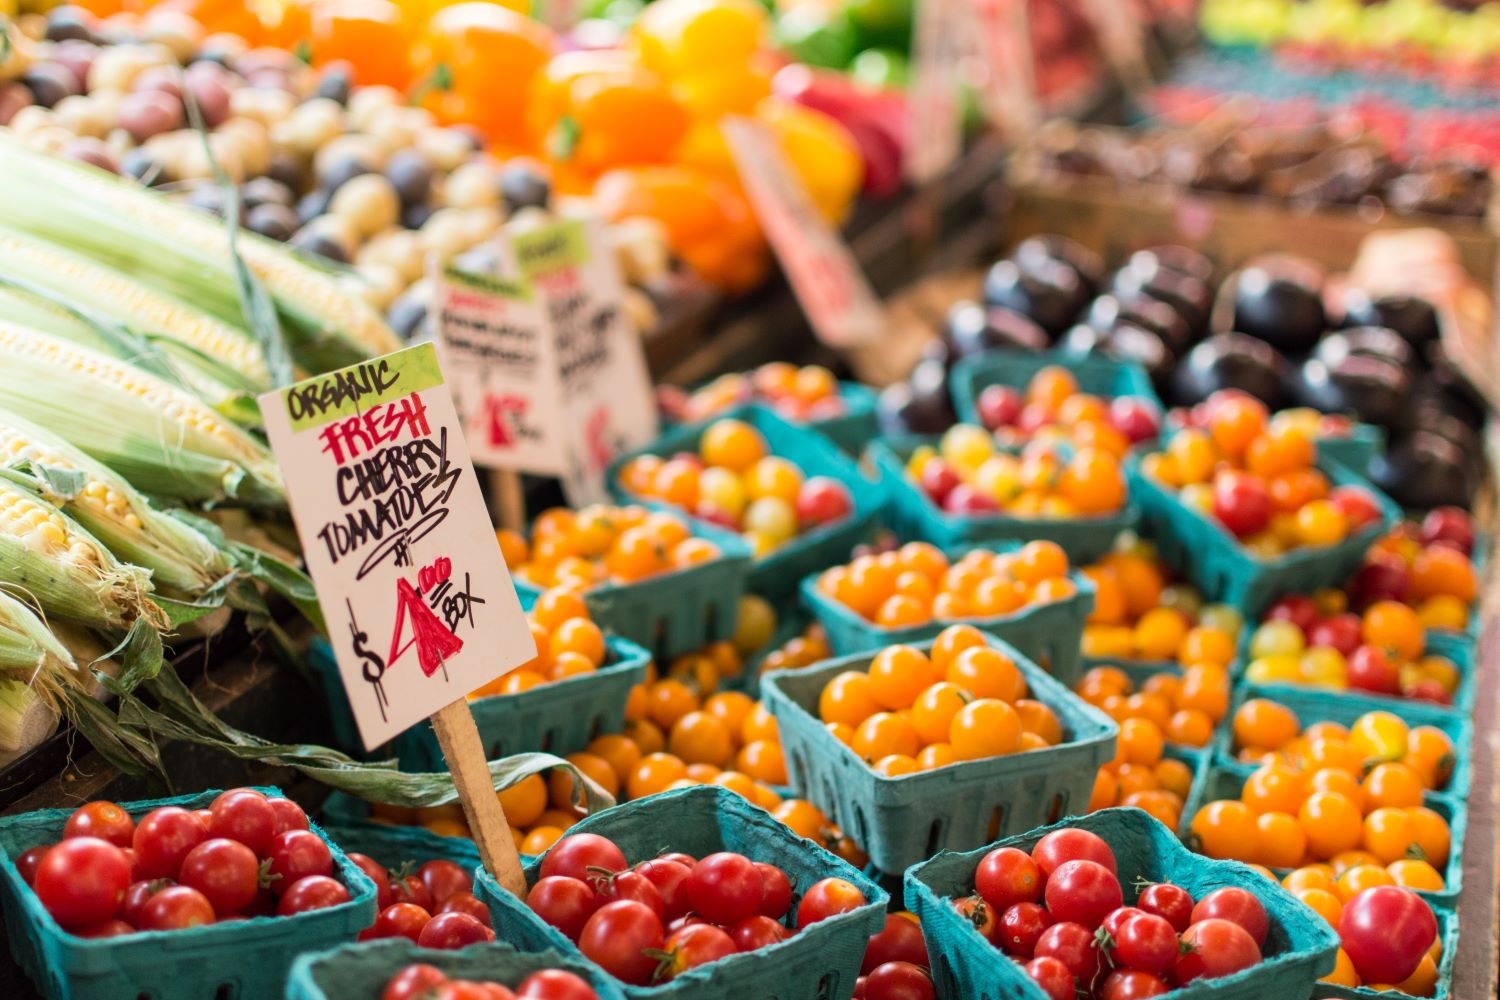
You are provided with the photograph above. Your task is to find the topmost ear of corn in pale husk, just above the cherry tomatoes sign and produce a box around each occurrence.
[0,132,402,370]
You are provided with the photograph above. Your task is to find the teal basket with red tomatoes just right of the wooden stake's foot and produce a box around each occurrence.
[476,786,888,1000]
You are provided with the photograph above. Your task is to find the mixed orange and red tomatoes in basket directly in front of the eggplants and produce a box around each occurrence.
[1140,393,1380,559]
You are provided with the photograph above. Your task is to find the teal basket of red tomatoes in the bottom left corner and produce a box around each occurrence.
[0,789,375,1000]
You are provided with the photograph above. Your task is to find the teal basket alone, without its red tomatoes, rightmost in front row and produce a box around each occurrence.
[906,808,1338,1000]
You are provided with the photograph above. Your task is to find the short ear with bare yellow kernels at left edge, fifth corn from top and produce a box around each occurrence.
[0,480,167,628]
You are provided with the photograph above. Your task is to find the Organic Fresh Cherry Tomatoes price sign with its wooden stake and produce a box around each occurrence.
[260,343,537,895]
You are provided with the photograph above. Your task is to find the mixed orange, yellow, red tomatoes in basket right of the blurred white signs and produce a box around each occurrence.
[620,418,854,556]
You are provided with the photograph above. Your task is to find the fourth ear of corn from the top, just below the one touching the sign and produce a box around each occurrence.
[0,409,231,597]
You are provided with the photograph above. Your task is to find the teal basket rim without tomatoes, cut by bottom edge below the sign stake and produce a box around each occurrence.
[283,939,621,1000]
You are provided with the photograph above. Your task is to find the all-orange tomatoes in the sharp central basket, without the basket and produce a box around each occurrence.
[818,625,1065,778]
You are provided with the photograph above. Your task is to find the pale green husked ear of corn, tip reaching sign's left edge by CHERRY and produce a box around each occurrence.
[0,322,285,505]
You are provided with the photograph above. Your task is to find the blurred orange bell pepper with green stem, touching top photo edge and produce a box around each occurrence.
[414,1,554,147]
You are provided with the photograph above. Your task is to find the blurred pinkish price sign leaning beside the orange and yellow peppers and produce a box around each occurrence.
[722,117,885,348]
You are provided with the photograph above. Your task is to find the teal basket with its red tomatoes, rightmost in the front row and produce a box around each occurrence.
[906,810,1338,1000]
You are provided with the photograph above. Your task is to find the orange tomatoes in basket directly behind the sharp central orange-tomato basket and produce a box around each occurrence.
[818,541,1079,628]
